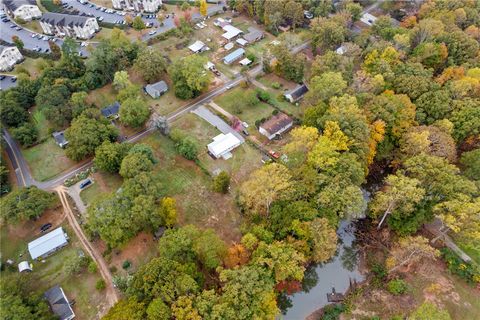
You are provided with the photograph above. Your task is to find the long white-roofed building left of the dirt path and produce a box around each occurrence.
[28,227,68,260]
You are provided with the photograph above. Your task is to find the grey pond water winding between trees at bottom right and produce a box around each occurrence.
[279,221,364,320]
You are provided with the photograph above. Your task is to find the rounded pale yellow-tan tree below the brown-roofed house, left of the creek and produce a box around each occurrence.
[240,163,292,216]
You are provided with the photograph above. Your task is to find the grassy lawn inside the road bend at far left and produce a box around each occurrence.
[22,138,76,181]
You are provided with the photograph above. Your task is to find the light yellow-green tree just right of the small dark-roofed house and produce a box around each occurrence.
[305,72,347,105]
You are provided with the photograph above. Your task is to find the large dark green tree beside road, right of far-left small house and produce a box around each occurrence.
[65,109,118,161]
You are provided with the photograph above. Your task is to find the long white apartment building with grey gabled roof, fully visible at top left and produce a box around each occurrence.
[40,12,100,39]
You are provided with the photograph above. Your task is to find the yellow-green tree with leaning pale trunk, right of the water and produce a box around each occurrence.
[370,175,425,231]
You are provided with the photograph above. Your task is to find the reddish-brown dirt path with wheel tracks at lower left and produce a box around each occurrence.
[55,186,119,313]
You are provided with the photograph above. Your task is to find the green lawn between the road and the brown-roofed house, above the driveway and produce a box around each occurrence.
[215,88,274,127]
